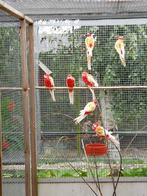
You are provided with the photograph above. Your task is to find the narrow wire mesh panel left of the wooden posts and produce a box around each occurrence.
[0,11,25,196]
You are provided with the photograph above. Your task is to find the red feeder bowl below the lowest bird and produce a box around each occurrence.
[85,143,108,156]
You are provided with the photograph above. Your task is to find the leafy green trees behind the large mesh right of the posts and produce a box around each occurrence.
[39,25,147,131]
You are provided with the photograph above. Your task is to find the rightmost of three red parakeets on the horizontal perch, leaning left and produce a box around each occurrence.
[82,71,98,100]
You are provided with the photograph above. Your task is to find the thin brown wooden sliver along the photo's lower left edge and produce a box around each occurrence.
[0,92,3,196]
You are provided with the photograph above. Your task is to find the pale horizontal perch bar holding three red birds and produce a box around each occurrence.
[36,86,147,90]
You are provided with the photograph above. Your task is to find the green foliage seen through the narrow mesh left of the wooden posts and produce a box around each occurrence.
[0,26,23,150]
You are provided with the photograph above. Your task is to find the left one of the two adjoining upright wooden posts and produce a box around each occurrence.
[20,20,31,196]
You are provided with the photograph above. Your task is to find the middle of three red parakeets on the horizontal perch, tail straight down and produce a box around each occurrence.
[66,74,75,104]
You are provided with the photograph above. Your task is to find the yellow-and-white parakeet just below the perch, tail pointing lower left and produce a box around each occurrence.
[74,100,97,124]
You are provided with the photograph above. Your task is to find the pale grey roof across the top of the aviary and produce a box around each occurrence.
[4,0,147,19]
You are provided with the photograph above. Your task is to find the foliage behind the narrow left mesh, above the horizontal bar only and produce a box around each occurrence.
[0,26,21,87]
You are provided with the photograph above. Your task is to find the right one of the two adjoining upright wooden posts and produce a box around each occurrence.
[29,24,38,196]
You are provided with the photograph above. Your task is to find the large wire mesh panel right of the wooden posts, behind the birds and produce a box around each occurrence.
[36,20,147,185]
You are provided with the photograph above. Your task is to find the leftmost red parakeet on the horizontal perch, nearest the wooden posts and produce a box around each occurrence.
[44,74,56,102]
